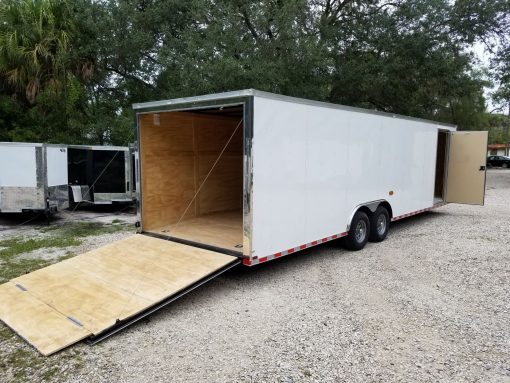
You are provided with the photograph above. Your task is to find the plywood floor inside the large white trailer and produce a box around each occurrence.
[148,210,243,253]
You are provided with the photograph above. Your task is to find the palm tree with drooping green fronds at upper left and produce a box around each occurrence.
[0,0,74,104]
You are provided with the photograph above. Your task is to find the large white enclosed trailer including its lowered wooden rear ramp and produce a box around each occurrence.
[0,90,487,355]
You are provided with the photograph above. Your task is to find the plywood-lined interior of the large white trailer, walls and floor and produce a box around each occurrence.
[138,106,244,254]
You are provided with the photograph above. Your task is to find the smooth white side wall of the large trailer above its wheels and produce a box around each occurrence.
[252,97,439,257]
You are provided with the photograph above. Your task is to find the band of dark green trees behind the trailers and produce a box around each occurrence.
[0,0,510,144]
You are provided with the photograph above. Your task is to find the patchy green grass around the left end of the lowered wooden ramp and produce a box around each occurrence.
[0,222,134,383]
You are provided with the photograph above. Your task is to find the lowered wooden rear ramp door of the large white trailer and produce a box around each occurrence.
[0,234,240,355]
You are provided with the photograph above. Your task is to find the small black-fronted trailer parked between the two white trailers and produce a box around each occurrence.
[68,145,134,205]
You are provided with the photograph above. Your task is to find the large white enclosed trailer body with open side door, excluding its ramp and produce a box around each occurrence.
[134,90,487,265]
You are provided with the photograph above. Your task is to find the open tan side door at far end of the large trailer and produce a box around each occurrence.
[446,132,488,205]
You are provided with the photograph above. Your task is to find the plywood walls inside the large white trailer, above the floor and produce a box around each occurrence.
[139,112,243,230]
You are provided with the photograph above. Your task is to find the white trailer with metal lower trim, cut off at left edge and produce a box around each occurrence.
[0,142,69,214]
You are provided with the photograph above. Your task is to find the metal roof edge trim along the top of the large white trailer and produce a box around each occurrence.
[133,89,457,129]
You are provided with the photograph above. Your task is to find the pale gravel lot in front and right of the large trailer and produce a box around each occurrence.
[0,170,510,382]
